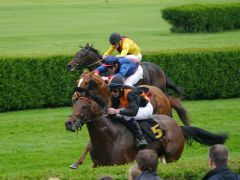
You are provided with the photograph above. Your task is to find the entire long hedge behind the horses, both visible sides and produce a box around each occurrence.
[0,49,240,111]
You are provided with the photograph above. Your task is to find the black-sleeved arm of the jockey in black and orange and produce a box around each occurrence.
[119,91,140,117]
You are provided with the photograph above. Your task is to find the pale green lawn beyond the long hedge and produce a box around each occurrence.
[0,0,240,56]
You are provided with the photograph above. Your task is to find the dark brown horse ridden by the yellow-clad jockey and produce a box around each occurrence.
[67,44,182,96]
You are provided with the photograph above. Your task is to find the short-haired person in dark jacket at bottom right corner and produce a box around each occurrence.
[203,144,240,180]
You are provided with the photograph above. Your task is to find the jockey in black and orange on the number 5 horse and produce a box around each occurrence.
[108,76,153,148]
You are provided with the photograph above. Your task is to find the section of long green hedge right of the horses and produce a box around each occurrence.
[144,50,240,99]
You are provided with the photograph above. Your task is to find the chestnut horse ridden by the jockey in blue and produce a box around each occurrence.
[72,72,190,126]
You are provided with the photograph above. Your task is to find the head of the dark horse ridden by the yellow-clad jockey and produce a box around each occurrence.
[67,43,102,71]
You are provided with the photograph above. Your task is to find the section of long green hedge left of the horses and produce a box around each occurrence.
[0,56,79,111]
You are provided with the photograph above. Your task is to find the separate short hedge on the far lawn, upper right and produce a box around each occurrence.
[162,3,240,32]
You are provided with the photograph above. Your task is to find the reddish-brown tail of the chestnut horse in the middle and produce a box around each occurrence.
[168,96,190,126]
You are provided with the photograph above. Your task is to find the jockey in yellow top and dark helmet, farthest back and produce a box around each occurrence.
[103,33,142,62]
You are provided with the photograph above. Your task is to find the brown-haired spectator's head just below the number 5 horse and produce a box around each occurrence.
[136,149,161,180]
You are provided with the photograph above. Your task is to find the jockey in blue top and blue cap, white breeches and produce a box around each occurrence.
[95,56,143,86]
